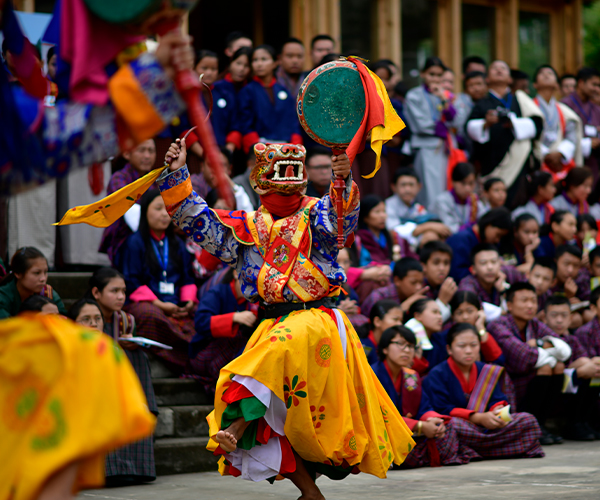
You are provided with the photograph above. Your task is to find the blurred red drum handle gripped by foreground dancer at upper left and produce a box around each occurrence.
[156,21,235,207]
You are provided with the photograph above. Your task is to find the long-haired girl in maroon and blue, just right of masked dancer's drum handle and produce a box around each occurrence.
[356,194,400,267]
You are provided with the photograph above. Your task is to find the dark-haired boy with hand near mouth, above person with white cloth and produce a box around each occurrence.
[419,241,457,322]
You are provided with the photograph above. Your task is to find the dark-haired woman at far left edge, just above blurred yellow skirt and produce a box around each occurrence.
[0,247,67,319]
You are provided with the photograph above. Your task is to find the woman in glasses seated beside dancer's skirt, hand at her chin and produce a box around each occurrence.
[373,326,479,469]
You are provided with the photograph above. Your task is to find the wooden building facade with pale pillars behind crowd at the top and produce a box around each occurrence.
[14,0,590,90]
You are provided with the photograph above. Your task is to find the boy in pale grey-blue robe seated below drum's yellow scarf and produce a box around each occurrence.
[385,167,451,246]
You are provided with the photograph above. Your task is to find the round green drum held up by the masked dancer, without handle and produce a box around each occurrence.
[296,60,366,152]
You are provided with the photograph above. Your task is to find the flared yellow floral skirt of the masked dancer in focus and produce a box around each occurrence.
[207,309,414,478]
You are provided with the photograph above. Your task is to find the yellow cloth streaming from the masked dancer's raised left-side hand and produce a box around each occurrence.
[53,168,164,227]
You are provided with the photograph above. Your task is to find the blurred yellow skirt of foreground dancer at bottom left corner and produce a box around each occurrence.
[0,315,156,500]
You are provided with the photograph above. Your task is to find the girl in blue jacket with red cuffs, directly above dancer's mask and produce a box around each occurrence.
[234,45,302,152]
